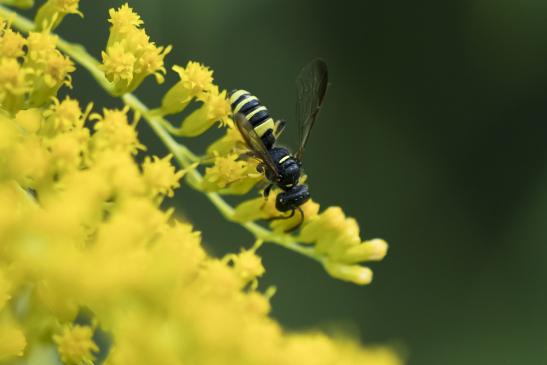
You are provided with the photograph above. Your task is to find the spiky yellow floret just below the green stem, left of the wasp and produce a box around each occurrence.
[142,154,184,197]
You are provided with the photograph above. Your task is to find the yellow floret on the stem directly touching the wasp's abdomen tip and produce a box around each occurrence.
[177,87,231,137]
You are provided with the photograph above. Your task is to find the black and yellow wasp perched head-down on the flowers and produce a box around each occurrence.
[230,59,328,231]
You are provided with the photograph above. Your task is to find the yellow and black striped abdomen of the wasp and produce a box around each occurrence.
[230,90,275,139]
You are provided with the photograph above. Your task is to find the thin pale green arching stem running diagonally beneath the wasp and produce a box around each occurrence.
[0,5,324,262]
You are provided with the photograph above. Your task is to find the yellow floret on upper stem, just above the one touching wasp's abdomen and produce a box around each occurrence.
[160,61,213,115]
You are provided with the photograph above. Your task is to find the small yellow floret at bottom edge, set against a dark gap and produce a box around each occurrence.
[53,324,99,365]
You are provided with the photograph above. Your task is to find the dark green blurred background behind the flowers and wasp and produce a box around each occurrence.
[31,0,547,365]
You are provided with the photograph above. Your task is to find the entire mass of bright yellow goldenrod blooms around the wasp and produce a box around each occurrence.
[0,1,400,365]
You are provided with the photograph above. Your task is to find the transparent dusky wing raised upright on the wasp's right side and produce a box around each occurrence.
[296,58,329,161]
